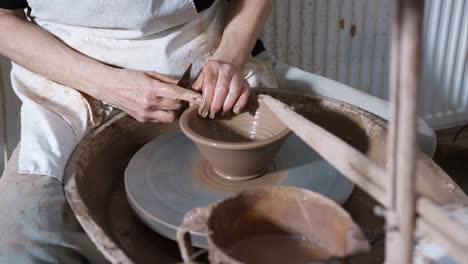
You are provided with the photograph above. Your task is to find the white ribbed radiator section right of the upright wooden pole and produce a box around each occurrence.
[421,0,468,127]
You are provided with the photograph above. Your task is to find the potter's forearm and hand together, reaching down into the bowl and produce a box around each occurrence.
[188,0,274,118]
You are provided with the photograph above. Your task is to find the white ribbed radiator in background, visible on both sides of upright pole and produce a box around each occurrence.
[262,0,468,128]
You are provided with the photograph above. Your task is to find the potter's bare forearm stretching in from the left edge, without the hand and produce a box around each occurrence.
[0,10,112,96]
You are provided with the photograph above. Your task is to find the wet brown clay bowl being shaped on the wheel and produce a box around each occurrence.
[179,97,291,181]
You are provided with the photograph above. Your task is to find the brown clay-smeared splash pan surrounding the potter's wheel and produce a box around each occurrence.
[65,89,464,263]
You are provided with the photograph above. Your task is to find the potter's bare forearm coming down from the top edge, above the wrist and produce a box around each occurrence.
[212,0,272,68]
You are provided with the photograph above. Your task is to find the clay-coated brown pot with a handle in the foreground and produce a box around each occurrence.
[177,186,370,264]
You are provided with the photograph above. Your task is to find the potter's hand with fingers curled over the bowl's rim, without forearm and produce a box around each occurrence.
[192,60,250,118]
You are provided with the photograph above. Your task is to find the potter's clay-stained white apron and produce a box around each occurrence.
[11,0,275,180]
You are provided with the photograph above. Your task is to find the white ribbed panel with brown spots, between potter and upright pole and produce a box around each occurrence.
[263,0,393,98]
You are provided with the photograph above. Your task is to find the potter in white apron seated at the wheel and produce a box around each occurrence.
[0,0,272,264]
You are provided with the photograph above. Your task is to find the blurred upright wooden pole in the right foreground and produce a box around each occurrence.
[386,0,424,263]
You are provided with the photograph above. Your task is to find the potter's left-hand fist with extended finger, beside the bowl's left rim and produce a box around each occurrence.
[94,69,201,123]
